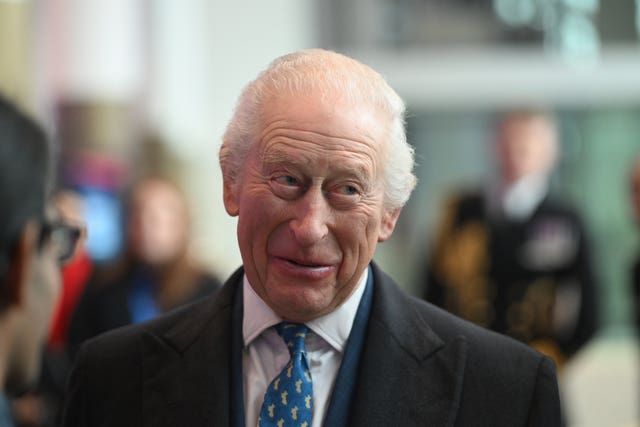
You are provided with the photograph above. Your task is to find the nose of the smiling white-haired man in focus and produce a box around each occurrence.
[289,188,330,246]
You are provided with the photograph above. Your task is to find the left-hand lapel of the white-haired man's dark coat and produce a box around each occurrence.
[141,272,242,427]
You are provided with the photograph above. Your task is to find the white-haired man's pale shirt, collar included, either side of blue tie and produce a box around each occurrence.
[242,268,369,427]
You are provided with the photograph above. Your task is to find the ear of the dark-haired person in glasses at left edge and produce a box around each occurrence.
[7,221,38,306]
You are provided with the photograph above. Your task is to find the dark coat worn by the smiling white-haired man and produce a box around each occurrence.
[63,265,560,427]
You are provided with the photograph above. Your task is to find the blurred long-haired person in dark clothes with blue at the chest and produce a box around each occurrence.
[69,177,220,357]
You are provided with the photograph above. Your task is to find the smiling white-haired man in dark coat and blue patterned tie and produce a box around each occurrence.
[60,50,560,427]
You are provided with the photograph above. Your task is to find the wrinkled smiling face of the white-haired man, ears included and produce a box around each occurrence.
[225,94,399,322]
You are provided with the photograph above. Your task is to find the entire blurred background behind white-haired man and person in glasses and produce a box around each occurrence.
[0,0,640,426]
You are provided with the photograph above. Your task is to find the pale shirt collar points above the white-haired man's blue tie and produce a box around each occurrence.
[242,267,369,353]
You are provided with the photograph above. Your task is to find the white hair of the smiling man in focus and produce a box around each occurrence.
[220,49,416,210]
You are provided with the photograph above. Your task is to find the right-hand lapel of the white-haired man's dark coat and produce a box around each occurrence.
[350,265,466,426]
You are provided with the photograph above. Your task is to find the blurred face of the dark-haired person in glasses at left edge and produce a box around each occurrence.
[7,213,61,392]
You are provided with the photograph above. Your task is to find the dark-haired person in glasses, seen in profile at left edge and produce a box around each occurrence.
[0,98,82,427]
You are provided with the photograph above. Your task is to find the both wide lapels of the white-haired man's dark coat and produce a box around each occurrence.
[141,264,466,426]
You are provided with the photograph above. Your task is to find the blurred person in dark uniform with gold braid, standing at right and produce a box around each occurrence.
[425,110,597,365]
